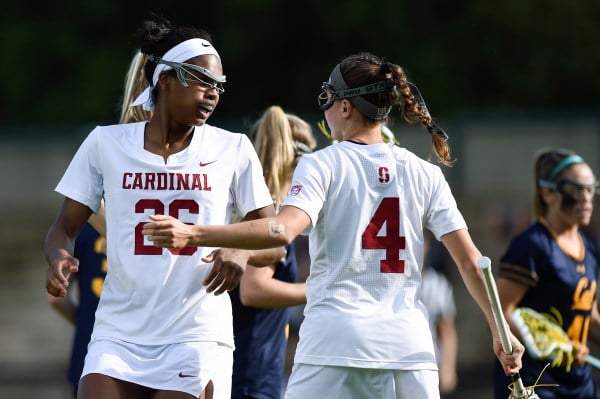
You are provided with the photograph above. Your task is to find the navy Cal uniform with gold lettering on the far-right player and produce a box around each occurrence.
[494,220,598,399]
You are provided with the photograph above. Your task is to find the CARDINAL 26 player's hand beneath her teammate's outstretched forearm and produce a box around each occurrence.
[202,248,248,295]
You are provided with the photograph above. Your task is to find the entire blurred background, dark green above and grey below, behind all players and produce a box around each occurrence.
[0,0,600,399]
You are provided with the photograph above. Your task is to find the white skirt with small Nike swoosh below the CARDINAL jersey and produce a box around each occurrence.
[81,339,233,399]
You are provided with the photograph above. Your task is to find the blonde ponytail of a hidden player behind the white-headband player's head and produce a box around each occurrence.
[119,51,152,123]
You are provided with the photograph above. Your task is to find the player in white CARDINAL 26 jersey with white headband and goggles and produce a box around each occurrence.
[45,19,284,399]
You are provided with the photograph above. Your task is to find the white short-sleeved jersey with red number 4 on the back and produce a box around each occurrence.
[283,141,466,370]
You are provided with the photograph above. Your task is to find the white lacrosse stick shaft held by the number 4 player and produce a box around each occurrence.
[477,256,539,399]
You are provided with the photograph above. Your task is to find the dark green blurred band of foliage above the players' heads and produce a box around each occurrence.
[0,0,600,125]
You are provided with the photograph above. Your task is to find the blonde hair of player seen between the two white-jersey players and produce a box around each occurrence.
[251,105,317,209]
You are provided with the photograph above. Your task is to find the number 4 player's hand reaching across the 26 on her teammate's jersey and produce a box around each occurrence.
[142,215,193,249]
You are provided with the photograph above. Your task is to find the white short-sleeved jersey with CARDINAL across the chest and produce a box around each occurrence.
[56,122,272,346]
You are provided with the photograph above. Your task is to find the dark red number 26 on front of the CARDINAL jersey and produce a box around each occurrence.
[134,199,200,255]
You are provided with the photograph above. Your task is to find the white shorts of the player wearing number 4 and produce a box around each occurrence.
[285,364,440,399]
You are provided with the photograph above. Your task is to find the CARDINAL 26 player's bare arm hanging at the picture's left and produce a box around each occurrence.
[44,198,92,297]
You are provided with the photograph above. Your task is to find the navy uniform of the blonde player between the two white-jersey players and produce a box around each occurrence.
[229,243,297,399]
